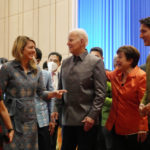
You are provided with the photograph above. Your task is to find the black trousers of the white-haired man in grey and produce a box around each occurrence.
[61,126,97,150]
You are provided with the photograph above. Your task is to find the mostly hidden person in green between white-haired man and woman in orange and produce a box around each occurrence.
[90,47,112,150]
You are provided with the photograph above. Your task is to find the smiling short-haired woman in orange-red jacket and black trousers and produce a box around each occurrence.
[106,46,148,150]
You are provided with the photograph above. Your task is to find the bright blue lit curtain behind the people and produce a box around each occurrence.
[78,0,150,70]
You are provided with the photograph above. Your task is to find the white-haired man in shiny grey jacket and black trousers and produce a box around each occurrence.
[54,29,106,150]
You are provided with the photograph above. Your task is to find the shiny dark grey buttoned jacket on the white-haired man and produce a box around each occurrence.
[52,52,106,126]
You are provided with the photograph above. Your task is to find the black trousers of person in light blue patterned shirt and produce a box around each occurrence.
[38,126,50,150]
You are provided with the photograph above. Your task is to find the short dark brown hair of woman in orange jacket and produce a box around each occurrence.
[117,46,140,68]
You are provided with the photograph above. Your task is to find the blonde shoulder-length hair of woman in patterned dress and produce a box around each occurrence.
[12,36,37,74]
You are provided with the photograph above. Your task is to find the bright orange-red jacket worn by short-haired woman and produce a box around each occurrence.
[106,67,148,135]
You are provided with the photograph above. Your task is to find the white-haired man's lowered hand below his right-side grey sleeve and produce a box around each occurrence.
[82,117,95,132]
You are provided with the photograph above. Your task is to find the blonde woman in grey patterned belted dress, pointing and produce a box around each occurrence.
[0,36,65,150]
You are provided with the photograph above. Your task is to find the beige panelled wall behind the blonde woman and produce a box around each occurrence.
[0,0,76,62]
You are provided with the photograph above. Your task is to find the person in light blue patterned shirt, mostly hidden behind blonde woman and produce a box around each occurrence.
[35,48,55,150]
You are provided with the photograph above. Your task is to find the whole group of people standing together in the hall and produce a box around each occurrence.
[0,17,150,150]
